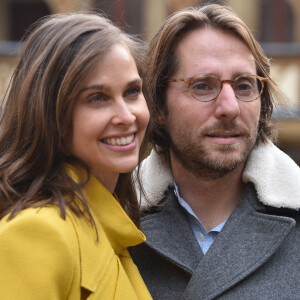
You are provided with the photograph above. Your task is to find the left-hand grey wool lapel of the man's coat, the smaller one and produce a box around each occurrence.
[141,190,203,274]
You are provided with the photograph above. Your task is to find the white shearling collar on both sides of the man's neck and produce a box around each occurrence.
[140,142,300,210]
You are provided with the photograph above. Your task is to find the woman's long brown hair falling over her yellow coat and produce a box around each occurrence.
[0,13,143,225]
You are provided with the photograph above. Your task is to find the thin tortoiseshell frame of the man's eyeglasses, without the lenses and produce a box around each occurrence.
[166,74,268,102]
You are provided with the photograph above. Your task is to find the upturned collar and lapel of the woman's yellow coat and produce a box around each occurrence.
[70,169,146,292]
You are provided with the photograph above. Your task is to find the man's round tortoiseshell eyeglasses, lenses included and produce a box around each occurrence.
[167,75,268,102]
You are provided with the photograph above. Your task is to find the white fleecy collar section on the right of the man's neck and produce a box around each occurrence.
[243,142,300,210]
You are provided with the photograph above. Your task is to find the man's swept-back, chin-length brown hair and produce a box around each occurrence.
[144,4,284,154]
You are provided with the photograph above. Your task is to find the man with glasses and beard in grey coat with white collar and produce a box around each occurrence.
[132,5,300,300]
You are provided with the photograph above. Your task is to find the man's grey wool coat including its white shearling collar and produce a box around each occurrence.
[131,143,300,300]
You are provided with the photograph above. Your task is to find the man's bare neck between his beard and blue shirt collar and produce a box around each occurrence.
[172,159,244,231]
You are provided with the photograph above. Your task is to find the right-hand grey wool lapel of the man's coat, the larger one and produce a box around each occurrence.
[183,185,295,300]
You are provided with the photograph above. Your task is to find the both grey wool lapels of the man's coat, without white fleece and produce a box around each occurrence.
[142,183,295,300]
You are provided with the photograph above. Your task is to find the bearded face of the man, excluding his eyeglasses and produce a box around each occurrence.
[163,29,261,178]
